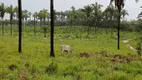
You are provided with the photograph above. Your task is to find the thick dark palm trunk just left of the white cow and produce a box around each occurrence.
[50,0,55,57]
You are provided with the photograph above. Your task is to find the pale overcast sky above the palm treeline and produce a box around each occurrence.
[0,0,142,20]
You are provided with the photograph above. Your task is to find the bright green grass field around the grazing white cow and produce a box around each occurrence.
[0,27,142,80]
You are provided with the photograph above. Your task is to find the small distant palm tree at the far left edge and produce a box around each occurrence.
[0,3,6,36]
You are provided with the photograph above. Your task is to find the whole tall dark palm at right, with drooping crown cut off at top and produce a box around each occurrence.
[110,0,139,50]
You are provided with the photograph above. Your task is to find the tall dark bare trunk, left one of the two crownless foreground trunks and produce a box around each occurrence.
[18,0,22,53]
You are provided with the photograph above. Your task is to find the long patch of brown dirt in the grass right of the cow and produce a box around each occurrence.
[80,51,142,64]
